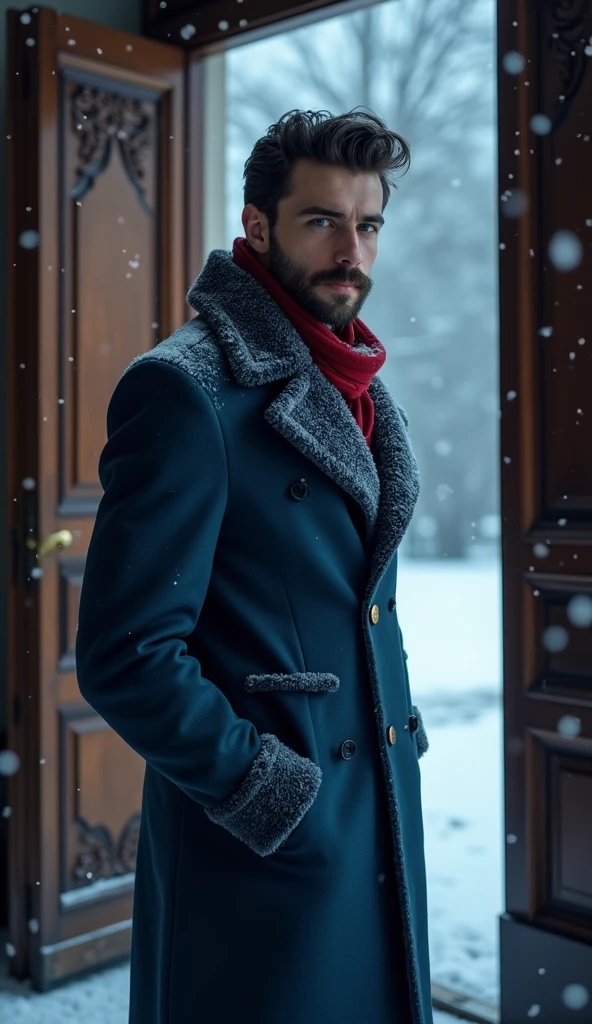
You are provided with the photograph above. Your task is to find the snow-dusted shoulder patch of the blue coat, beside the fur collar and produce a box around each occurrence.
[122,315,231,409]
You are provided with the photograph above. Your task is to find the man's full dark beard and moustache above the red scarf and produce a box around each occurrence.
[267,231,374,331]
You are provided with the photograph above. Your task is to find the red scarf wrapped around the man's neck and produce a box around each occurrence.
[232,239,386,451]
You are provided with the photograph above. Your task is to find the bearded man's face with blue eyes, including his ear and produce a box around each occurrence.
[243,160,382,331]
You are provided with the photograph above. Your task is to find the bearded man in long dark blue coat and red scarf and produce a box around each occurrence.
[77,111,432,1024]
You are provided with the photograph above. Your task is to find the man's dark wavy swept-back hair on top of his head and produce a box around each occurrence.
[244,109,411,228]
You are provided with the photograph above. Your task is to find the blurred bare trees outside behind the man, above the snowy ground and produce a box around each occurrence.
[223,0,498,558]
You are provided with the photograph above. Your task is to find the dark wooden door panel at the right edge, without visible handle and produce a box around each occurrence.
[498,0,592,1024]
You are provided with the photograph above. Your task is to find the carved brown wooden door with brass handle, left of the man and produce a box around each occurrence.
[7,7,184,989]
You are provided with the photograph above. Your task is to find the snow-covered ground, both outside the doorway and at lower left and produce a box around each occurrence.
[0,559,504,1024]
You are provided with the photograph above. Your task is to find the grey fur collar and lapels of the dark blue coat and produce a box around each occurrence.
[187,249,419,594]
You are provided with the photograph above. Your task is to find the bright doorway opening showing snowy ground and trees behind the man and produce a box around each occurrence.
[203,0,497,1007]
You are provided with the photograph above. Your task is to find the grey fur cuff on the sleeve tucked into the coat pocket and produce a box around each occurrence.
[204,732,323,857]
